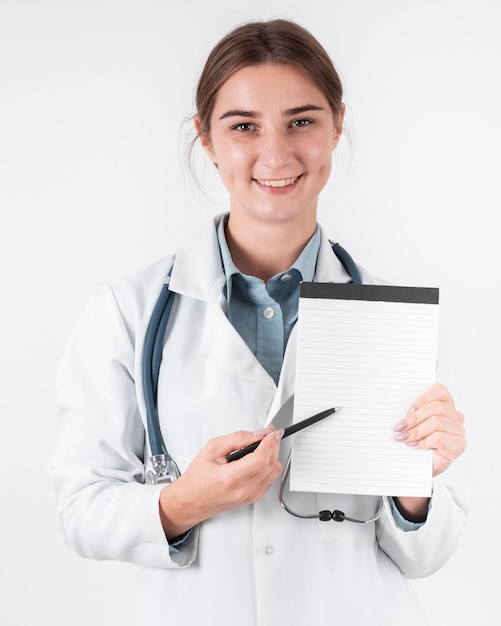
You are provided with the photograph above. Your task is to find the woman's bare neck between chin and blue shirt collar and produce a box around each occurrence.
[226,213,316,282]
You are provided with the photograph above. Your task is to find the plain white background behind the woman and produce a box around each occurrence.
[0,0,501,626]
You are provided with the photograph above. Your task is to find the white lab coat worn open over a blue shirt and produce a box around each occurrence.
[49,214,466,626]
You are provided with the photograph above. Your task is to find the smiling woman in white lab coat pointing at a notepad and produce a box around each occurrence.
[50,20,466,626]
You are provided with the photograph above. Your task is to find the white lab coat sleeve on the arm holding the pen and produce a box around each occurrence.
[49,286,198,568]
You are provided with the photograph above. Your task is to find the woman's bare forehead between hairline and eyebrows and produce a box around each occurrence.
[214,63,330,115]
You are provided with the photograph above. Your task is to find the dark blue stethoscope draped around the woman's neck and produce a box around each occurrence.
[142,242,383,524]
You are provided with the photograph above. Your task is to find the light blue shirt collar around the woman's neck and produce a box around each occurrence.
[217,213,321,300]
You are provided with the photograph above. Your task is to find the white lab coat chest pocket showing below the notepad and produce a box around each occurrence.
[316,493,379,543]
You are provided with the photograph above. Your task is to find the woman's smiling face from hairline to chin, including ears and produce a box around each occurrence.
[197,63,342,229]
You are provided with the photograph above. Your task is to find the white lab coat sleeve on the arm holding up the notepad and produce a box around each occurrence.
[377,455,468,579]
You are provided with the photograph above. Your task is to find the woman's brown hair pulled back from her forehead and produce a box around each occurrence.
[195,19,343,135]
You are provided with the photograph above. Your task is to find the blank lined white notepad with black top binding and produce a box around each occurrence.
[290,283,438,496]
